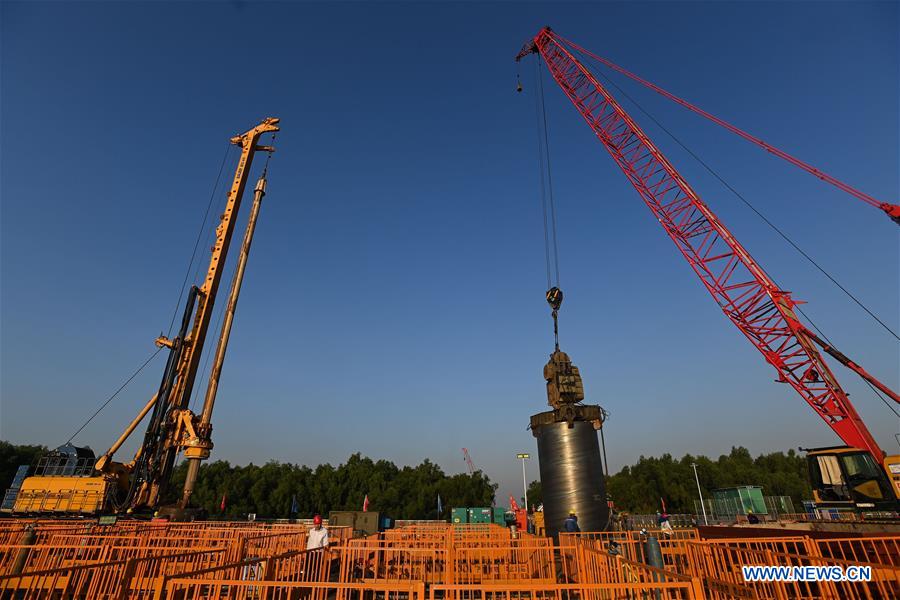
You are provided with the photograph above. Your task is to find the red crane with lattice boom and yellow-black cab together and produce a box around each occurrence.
[516,27,900,510]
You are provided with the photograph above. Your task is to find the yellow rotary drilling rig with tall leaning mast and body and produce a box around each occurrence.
[13,118,279,516]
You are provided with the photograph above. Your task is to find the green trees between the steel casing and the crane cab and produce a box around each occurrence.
[604,447,812,513]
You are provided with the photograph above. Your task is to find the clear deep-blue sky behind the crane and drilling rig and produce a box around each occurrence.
[0,2,900,498]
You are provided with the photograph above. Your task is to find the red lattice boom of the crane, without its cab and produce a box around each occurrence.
[517,28,884,459]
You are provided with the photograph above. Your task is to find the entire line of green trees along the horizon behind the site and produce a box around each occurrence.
[0,441,811,519]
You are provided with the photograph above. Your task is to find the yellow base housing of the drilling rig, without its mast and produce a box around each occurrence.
[13,475,116,514]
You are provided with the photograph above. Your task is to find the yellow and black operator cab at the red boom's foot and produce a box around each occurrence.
[806,446,900,513]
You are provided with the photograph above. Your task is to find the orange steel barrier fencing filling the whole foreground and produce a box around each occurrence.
[0,522,900,600]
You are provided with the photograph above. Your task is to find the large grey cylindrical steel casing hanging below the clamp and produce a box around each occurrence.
[533,421,609,540]
